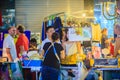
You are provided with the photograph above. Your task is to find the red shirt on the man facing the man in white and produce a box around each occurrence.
[16,34,29,58]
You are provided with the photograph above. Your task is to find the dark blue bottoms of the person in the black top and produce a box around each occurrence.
[41,66,60,80]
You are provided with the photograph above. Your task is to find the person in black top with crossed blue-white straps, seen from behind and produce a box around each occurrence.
[41,32,65,80]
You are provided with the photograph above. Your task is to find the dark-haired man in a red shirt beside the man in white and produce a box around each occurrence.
[16,25,29,58]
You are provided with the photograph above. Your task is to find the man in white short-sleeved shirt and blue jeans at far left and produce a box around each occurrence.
[3,26,23,80]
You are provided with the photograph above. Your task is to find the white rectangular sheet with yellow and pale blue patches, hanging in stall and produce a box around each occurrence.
[68,27,91,41]
